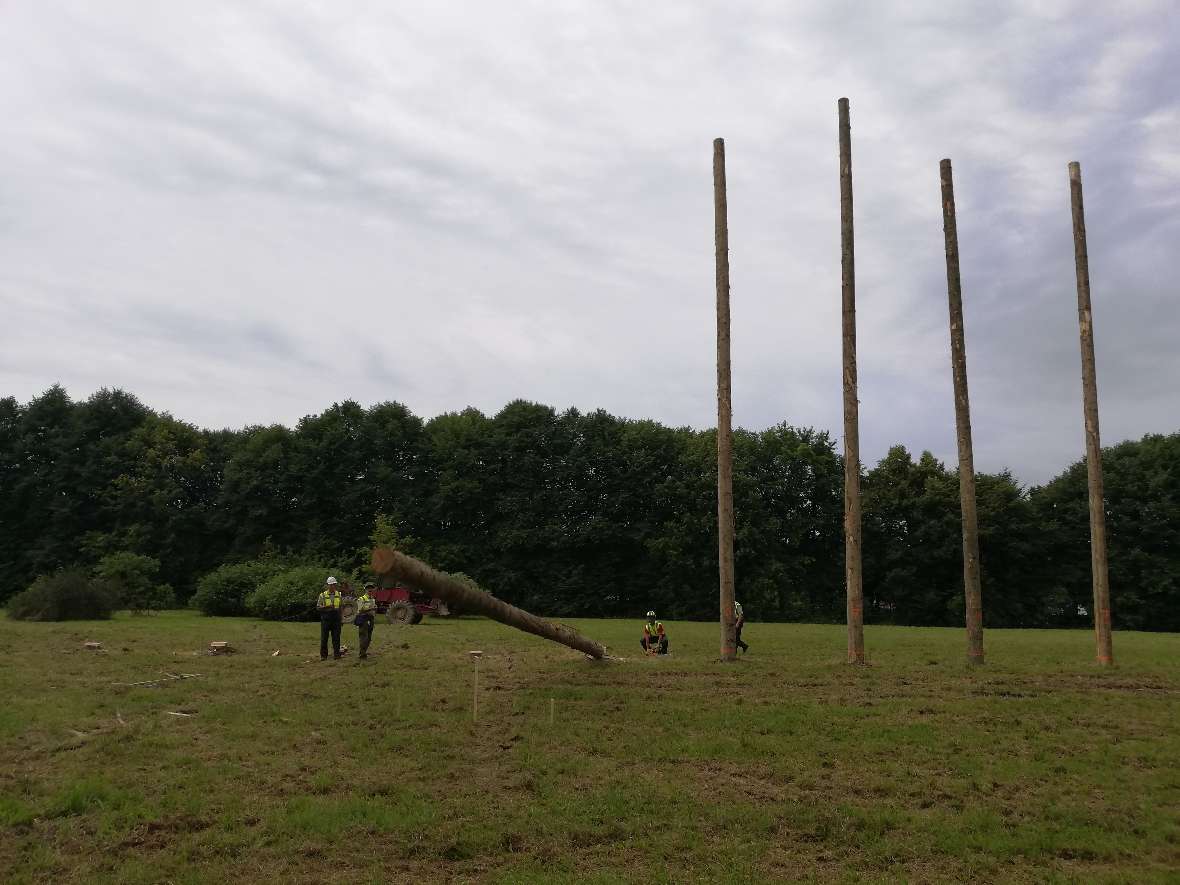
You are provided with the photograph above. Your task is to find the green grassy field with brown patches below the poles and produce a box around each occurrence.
[0,612,1180,883]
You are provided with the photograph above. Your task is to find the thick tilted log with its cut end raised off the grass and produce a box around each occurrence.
[373,548,607,660]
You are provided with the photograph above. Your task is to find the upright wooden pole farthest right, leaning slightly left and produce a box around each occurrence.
[1069,163,1114,666]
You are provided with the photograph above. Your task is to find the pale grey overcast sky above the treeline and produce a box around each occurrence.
[0,0,1180,483]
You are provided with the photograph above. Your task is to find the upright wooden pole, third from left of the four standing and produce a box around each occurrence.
[938,159,983,663]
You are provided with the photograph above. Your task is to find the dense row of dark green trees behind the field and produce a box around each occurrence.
[0,387,1180,630]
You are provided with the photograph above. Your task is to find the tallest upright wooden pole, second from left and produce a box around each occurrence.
[838,98,865,663]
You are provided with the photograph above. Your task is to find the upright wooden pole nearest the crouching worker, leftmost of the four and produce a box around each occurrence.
[713,138,738,661]
